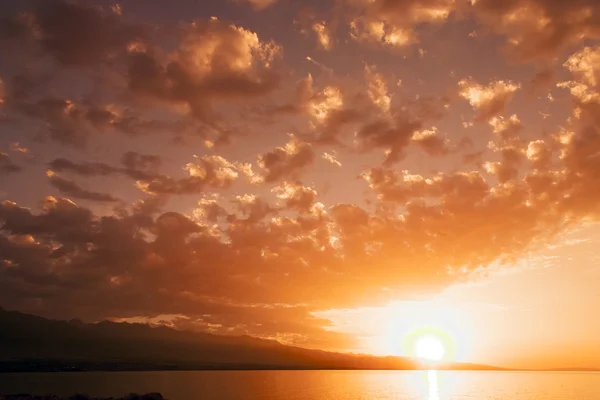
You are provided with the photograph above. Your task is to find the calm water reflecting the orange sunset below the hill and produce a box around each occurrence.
[0,371,600,400]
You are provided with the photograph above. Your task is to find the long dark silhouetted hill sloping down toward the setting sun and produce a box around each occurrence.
[0,309,502,371]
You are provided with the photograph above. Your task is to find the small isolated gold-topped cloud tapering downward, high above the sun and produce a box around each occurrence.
[458,79,521,121]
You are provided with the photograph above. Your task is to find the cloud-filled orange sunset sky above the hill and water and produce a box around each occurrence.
[0,0,600,368]
